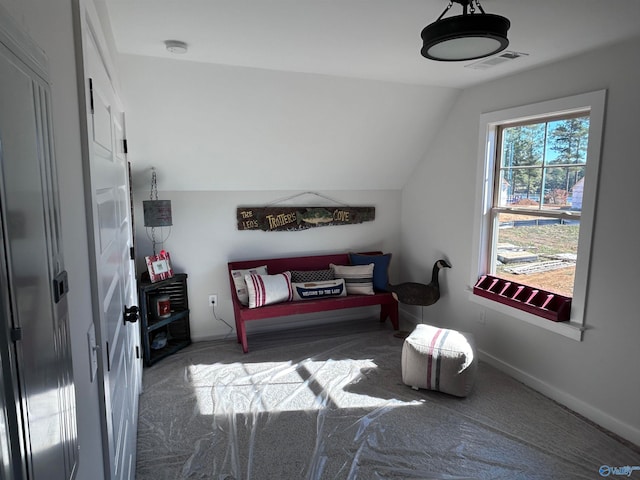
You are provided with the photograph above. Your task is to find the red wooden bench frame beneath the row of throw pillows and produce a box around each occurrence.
[228,252,399,353]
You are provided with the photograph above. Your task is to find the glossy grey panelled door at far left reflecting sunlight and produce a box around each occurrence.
[0,18,78,480]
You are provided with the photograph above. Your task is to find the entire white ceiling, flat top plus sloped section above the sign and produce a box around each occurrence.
[102,0,640,190]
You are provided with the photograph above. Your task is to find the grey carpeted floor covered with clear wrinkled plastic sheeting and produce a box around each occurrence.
[137,319,640,480]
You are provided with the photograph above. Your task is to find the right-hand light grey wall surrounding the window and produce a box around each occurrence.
[401,35,640,444]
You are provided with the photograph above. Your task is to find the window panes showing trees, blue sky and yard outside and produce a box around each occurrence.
[490,113,589,297]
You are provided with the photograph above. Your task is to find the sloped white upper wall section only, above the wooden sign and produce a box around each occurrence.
[118,53,459,191]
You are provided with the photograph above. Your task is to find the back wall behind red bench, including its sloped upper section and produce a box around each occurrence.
[118,53,424,341]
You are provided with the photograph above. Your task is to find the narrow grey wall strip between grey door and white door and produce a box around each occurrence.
[0,0,104,480]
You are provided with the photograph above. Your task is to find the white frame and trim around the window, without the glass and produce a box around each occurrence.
[469,90,606,341]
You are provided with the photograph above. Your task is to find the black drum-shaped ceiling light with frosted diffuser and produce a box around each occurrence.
[420,0,511,62]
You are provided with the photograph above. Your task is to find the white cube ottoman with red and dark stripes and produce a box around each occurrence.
[402,324,478,397]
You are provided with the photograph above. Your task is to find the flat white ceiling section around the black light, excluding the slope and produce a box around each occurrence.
[106,0,640,88]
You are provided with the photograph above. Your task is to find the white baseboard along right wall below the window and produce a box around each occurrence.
[478,350,640,445]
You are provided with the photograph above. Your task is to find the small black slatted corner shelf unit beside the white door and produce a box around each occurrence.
[139,273,191,367]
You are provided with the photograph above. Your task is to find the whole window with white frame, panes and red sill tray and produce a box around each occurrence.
[471,91,605,339]
